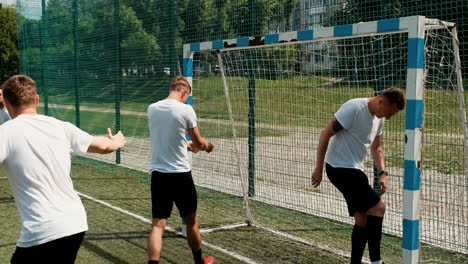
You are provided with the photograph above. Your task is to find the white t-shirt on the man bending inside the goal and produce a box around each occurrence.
[325,98,384,170]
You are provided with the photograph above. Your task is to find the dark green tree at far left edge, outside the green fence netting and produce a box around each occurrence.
[0,3,19,83]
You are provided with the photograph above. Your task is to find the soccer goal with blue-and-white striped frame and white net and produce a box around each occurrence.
[183,16,468,263]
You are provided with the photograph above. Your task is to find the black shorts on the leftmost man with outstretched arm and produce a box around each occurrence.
[11,232,85,264]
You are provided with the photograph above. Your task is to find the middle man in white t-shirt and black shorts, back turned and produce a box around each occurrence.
[148,76,214,264]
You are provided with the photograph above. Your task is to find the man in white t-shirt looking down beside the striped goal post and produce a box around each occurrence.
[312,88,405,264]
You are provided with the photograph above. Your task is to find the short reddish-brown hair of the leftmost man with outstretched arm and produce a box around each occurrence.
[1,75,37,107]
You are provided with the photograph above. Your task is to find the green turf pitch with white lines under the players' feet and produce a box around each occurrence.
[0,158,468,264]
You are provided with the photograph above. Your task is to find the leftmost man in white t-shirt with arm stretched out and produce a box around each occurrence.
[0,75,126,264]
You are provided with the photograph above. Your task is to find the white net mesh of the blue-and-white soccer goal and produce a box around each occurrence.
[193,23,468,253]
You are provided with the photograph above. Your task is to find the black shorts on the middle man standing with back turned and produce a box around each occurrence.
[151,171,197,219]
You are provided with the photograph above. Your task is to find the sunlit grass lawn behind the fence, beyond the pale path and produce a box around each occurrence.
[41,76,466,174]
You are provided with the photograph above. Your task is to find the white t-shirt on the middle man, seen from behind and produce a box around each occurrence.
[148,99,197,173]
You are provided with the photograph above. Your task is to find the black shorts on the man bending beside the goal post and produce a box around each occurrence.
[326,164,380,216]
